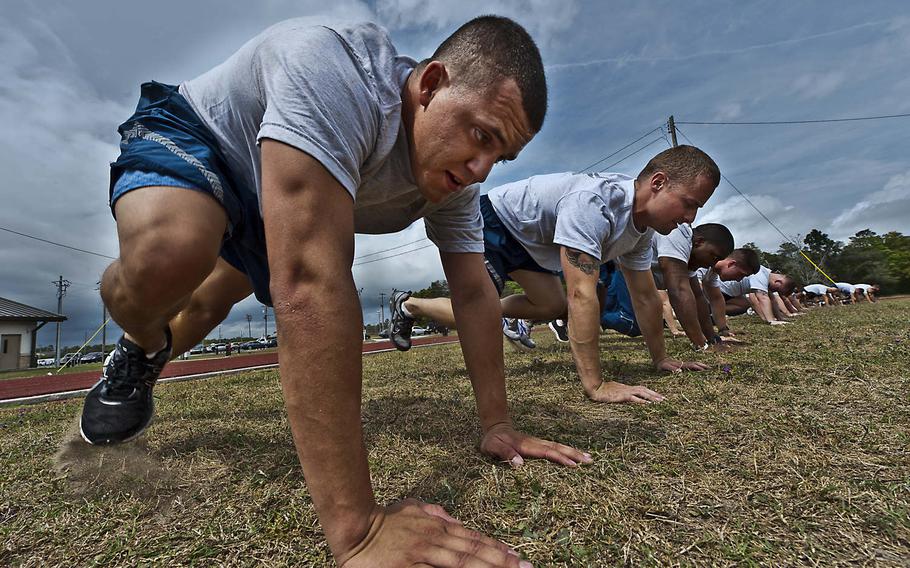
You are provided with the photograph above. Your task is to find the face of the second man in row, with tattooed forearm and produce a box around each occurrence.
[645,172,717,235]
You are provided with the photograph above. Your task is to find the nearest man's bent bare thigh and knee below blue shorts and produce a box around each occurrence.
[101,187,227,352]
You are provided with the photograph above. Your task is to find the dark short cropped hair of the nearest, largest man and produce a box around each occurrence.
[417,16,547,132]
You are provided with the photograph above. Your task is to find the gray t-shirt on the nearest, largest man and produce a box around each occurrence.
[180,18,483,252]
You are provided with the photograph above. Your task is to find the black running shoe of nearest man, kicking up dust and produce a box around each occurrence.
[79,329,171,445]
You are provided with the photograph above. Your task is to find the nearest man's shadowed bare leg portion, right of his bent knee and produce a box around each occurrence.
[170,258,253,356]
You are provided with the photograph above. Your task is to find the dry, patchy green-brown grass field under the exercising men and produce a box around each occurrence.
[0,299,910,567]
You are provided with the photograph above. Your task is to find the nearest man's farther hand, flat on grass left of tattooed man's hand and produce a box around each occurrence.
[480,424,592,467]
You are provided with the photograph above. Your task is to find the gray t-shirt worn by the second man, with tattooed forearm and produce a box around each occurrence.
[488,172,654,271]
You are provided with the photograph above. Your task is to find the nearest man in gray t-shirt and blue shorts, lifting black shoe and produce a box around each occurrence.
[80,16,590,568]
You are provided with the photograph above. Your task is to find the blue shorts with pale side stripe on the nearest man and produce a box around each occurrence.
[110,81,272,305]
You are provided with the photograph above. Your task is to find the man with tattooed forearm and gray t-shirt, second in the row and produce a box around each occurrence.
[393,146,720,403]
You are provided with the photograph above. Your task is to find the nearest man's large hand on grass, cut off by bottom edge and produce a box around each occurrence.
[338,499,531,568]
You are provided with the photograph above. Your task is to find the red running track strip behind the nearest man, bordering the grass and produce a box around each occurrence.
[0,336,458,401]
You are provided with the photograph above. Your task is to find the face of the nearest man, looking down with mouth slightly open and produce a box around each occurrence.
[410,62,534,203]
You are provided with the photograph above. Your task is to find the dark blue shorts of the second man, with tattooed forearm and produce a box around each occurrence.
[480,195,559,294]
